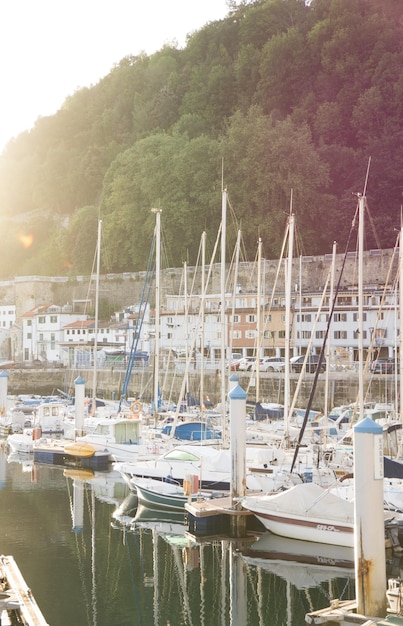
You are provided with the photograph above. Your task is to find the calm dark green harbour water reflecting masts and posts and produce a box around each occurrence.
[0,448,355,626]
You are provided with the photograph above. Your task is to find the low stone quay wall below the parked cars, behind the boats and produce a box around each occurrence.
[3,368,396,412]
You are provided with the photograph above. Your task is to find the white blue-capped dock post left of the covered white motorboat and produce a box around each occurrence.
[228,385,247,537]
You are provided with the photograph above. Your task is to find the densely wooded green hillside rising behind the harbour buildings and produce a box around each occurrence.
[0,0,403,278]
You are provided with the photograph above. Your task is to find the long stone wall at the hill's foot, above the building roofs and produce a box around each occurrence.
[0,249,398,321]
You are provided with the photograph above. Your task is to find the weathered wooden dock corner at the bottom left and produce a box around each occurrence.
[0,556,49,626]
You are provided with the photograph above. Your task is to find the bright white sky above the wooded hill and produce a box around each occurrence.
[0,0,228,151]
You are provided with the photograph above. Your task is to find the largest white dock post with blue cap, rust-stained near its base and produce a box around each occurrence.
[354,417,387,617]
